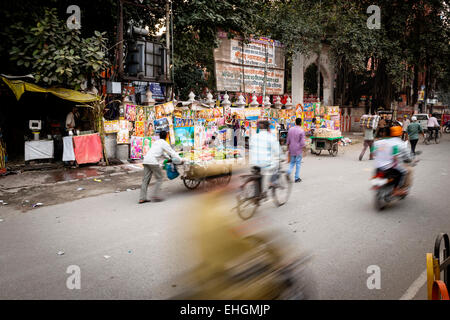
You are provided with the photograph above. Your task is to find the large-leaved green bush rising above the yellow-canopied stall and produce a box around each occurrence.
[9,9,109,89]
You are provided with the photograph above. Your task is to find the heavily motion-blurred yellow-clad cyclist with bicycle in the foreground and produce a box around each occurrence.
[172,182,317,300]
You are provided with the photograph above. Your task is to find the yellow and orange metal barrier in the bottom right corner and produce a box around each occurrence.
[426,233,450,300]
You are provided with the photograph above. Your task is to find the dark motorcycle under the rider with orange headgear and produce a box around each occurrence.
[371,159,418,211]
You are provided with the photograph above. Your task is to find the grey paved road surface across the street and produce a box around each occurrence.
[0,135,450,299]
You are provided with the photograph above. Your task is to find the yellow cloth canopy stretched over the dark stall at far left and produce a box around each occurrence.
[1,76,99,103]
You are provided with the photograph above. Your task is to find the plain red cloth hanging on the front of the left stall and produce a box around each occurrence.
[73,133,103,164]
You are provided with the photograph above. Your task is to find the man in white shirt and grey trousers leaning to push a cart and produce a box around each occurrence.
[139,131,182,203]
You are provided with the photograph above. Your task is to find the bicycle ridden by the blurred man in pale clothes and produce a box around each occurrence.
[236,162,292,220]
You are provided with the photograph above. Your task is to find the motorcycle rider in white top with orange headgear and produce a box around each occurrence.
[374,126,410,196]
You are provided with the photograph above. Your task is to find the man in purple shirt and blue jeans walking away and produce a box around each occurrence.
[286,118,306,182]
